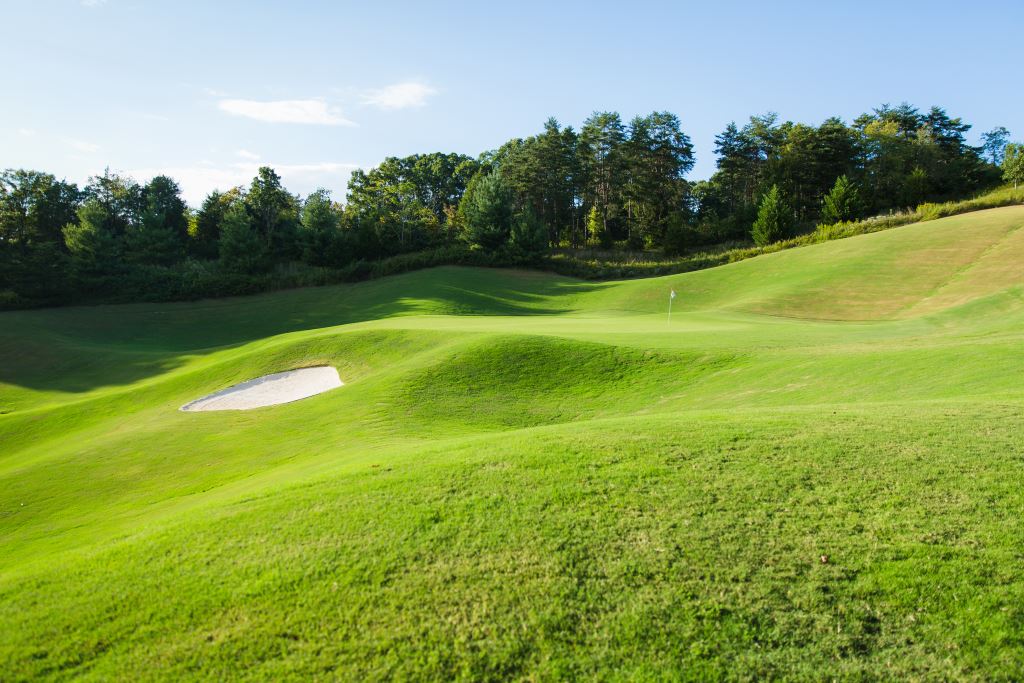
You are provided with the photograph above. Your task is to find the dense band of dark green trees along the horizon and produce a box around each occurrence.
[0,104,1024,306]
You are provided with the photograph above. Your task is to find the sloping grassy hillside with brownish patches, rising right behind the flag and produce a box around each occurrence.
[604,206,1024,321]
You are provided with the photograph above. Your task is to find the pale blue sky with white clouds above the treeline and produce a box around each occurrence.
[0,0,1024,204]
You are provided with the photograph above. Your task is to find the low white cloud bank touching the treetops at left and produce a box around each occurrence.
[124,161,358,207]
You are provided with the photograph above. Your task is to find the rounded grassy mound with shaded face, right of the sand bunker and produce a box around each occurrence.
[394,336,732,432]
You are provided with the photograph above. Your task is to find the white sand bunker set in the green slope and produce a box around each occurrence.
[181,366,343,412]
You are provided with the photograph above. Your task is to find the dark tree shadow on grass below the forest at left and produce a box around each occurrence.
[0,266,607,395]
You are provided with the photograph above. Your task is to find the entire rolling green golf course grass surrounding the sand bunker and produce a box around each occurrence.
[0,207,1024,681]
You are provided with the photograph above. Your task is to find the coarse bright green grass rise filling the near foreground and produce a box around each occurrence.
[6,407,1024,680]
